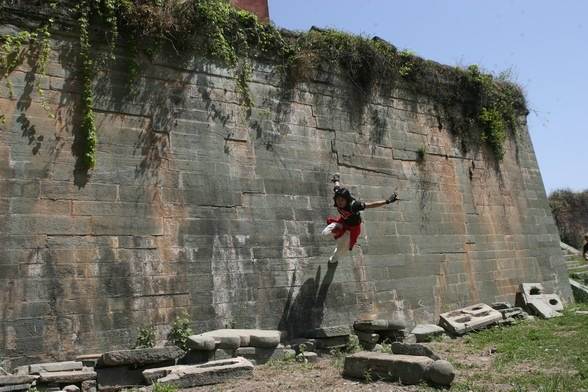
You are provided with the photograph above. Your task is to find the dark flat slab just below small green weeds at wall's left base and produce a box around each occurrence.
[98,346,185,367]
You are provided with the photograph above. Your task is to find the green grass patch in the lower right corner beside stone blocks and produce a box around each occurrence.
[451,305,588,392]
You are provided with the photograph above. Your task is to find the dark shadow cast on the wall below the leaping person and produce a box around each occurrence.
[278,264,337,338]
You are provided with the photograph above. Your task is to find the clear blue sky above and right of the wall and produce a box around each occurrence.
[269,0,588,192]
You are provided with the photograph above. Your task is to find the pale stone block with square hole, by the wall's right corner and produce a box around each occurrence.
[516,283,563,319]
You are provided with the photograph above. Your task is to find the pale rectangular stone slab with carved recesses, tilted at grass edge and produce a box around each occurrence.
[439,303,502,335]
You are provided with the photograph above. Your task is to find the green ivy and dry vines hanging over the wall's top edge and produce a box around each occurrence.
[0,0,526,171]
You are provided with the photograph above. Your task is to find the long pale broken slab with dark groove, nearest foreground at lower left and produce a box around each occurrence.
[143,357,253,388]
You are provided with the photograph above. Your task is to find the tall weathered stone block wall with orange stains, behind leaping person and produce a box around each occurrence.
[0,26,570,365]
